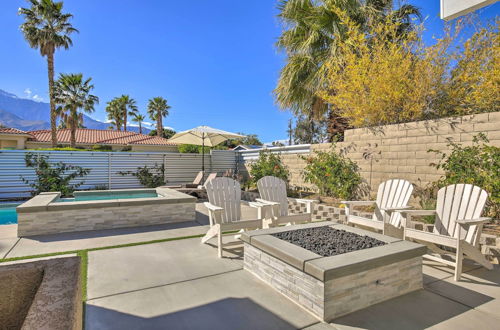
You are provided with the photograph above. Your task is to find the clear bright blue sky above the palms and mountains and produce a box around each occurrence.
[0,0,500,142]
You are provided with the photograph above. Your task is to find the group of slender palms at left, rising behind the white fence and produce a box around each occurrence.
[19,0,170,147]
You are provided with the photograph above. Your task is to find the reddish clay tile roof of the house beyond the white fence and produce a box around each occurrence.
[29,128,176,146]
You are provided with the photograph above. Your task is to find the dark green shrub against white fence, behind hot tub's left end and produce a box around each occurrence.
[21,152,90,196]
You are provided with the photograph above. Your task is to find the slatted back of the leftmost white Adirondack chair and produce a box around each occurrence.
[205,178,241,223]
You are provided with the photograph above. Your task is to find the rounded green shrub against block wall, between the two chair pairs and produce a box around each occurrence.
[301,145,361,199]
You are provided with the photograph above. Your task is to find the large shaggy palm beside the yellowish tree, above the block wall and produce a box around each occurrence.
[274,0,421,140]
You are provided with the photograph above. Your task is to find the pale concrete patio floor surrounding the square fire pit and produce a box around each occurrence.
[0,204,500,329]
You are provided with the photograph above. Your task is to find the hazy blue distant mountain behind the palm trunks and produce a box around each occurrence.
[0,89,150,134]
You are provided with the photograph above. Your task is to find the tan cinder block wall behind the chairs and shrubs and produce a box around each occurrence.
[240,112,500,191]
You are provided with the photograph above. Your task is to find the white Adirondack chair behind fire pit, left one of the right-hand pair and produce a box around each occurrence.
[342,179,413,238]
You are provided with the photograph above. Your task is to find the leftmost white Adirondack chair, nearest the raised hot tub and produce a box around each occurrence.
[201,178,265,258]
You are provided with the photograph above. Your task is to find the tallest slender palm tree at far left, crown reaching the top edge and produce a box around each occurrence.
[19,0,78,147]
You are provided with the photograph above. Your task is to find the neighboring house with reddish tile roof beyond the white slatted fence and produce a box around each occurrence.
[0,128,177,152]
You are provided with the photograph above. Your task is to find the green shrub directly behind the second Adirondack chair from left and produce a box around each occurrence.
[250,151,290,184]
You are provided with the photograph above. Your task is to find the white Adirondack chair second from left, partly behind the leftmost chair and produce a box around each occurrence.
[256,176,316,227]
